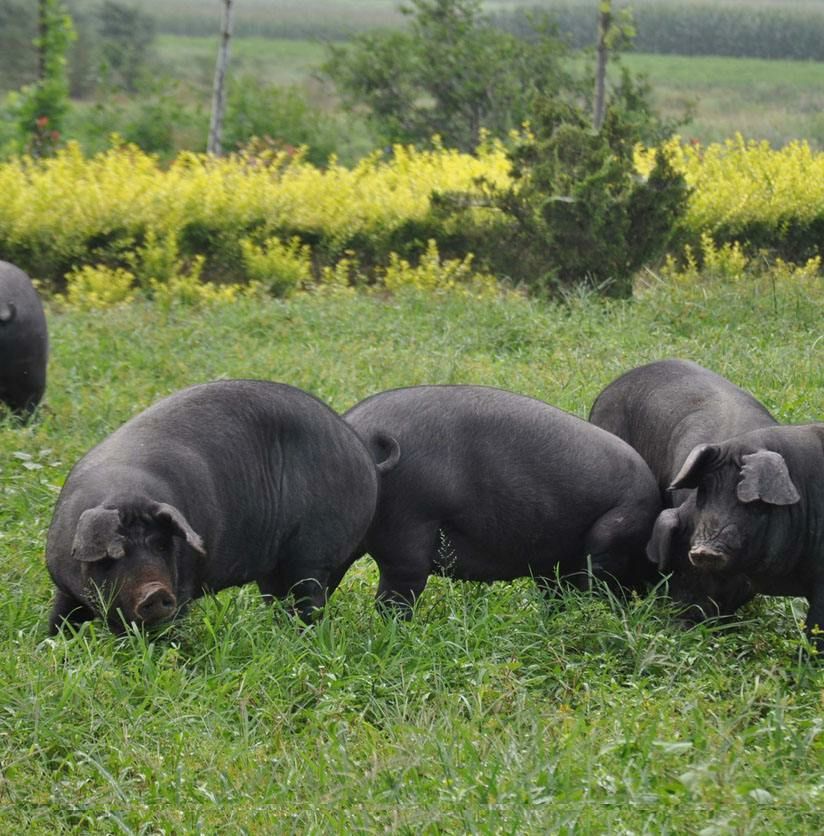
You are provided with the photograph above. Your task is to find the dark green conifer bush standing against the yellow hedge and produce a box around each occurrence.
[486,99,689,297]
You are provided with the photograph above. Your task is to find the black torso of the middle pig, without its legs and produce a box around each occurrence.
[344,385,658,541]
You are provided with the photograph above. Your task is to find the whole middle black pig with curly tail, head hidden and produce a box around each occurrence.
[344,385,661,614]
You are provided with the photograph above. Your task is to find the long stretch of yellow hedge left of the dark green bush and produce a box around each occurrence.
[0,136,509,282]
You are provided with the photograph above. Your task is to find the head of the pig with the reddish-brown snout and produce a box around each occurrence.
[49,497,205,632]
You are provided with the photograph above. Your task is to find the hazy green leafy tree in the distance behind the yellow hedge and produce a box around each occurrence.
[323,0,574,151]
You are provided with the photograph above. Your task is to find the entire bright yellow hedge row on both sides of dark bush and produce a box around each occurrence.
[0,137,824,287]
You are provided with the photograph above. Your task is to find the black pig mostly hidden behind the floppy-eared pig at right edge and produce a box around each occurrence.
[589,360,777,621]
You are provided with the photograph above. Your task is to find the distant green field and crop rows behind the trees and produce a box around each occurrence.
[9,0,824,152]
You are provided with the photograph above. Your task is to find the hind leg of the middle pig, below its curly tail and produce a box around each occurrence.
[368,521,439,618]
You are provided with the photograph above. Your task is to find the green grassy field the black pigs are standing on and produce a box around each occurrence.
[0,276,824,834]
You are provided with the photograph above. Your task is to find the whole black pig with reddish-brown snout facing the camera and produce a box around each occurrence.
[46,380,377,632]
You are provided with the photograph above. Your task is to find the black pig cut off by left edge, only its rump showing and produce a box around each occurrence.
[0,261,49,416]
